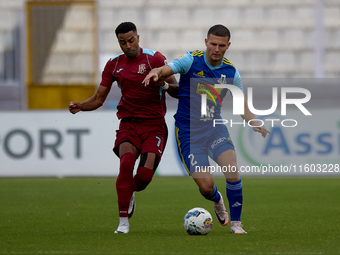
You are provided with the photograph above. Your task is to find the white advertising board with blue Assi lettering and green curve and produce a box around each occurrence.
[219,108,340,177]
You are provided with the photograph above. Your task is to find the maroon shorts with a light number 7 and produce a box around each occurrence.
[113,118,168,158]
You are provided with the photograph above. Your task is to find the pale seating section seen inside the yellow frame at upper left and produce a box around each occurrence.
[42,3,95,84]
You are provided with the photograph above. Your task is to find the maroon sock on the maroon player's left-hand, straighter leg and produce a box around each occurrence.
[116,152,136,217]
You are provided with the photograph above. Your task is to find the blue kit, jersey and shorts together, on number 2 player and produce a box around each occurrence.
[168,51,243,174]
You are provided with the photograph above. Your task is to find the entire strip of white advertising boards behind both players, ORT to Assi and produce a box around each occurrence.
[0,109,340,177]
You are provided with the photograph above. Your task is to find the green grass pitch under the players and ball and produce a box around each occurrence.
[0,177,340,255]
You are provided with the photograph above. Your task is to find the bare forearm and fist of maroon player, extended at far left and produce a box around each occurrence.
[68,86,111,114]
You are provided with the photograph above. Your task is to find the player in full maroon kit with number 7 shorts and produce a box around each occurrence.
[69,22,178,233]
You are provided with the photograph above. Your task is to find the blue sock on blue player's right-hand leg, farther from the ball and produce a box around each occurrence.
[227,180,243,221]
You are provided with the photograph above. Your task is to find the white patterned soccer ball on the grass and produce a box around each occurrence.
[183,207,213,235]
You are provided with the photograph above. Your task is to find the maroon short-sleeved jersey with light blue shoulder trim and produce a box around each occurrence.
[100,48,166,119]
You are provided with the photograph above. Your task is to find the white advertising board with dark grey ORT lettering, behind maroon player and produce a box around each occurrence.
[0,111,183,177]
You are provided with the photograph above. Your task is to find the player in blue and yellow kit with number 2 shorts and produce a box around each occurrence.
[144,25,270,234]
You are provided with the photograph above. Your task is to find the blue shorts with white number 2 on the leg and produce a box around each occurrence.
[176,125,234,175]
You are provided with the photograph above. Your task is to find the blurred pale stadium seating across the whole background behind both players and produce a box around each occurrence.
[0,0,340,109]
